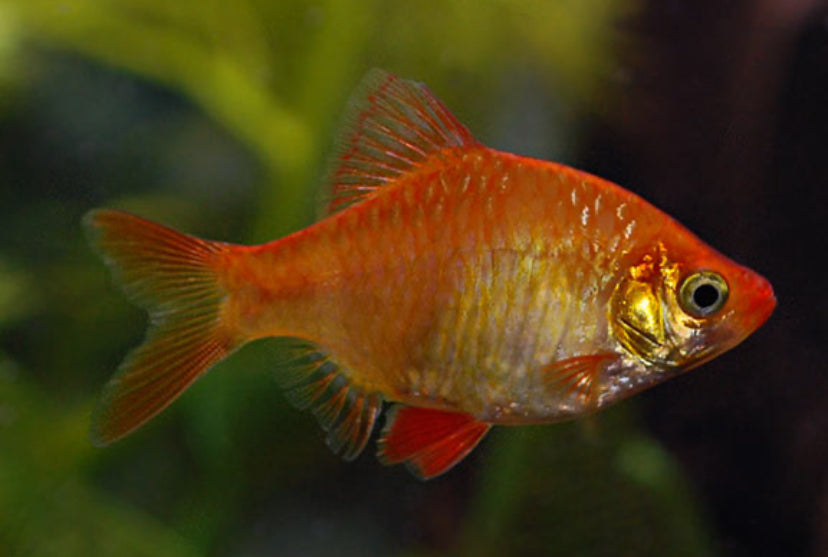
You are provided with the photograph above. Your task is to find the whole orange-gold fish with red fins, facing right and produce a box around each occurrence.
[84,70,776,479]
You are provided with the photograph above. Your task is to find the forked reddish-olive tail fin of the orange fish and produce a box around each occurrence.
[83,210,239,445]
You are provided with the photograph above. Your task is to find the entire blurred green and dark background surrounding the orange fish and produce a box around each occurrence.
[0,0,828,557]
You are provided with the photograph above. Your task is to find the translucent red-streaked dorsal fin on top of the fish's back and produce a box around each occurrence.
[329,69,477,212]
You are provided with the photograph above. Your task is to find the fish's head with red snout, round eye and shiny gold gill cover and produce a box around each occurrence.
[608,230,776,386]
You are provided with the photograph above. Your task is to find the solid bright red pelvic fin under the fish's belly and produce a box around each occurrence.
[378,406,491,479]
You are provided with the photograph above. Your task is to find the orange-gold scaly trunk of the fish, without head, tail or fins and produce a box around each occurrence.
[228,147,663,423]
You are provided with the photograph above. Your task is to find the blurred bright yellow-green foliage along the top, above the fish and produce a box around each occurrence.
[0,0,636,239]
